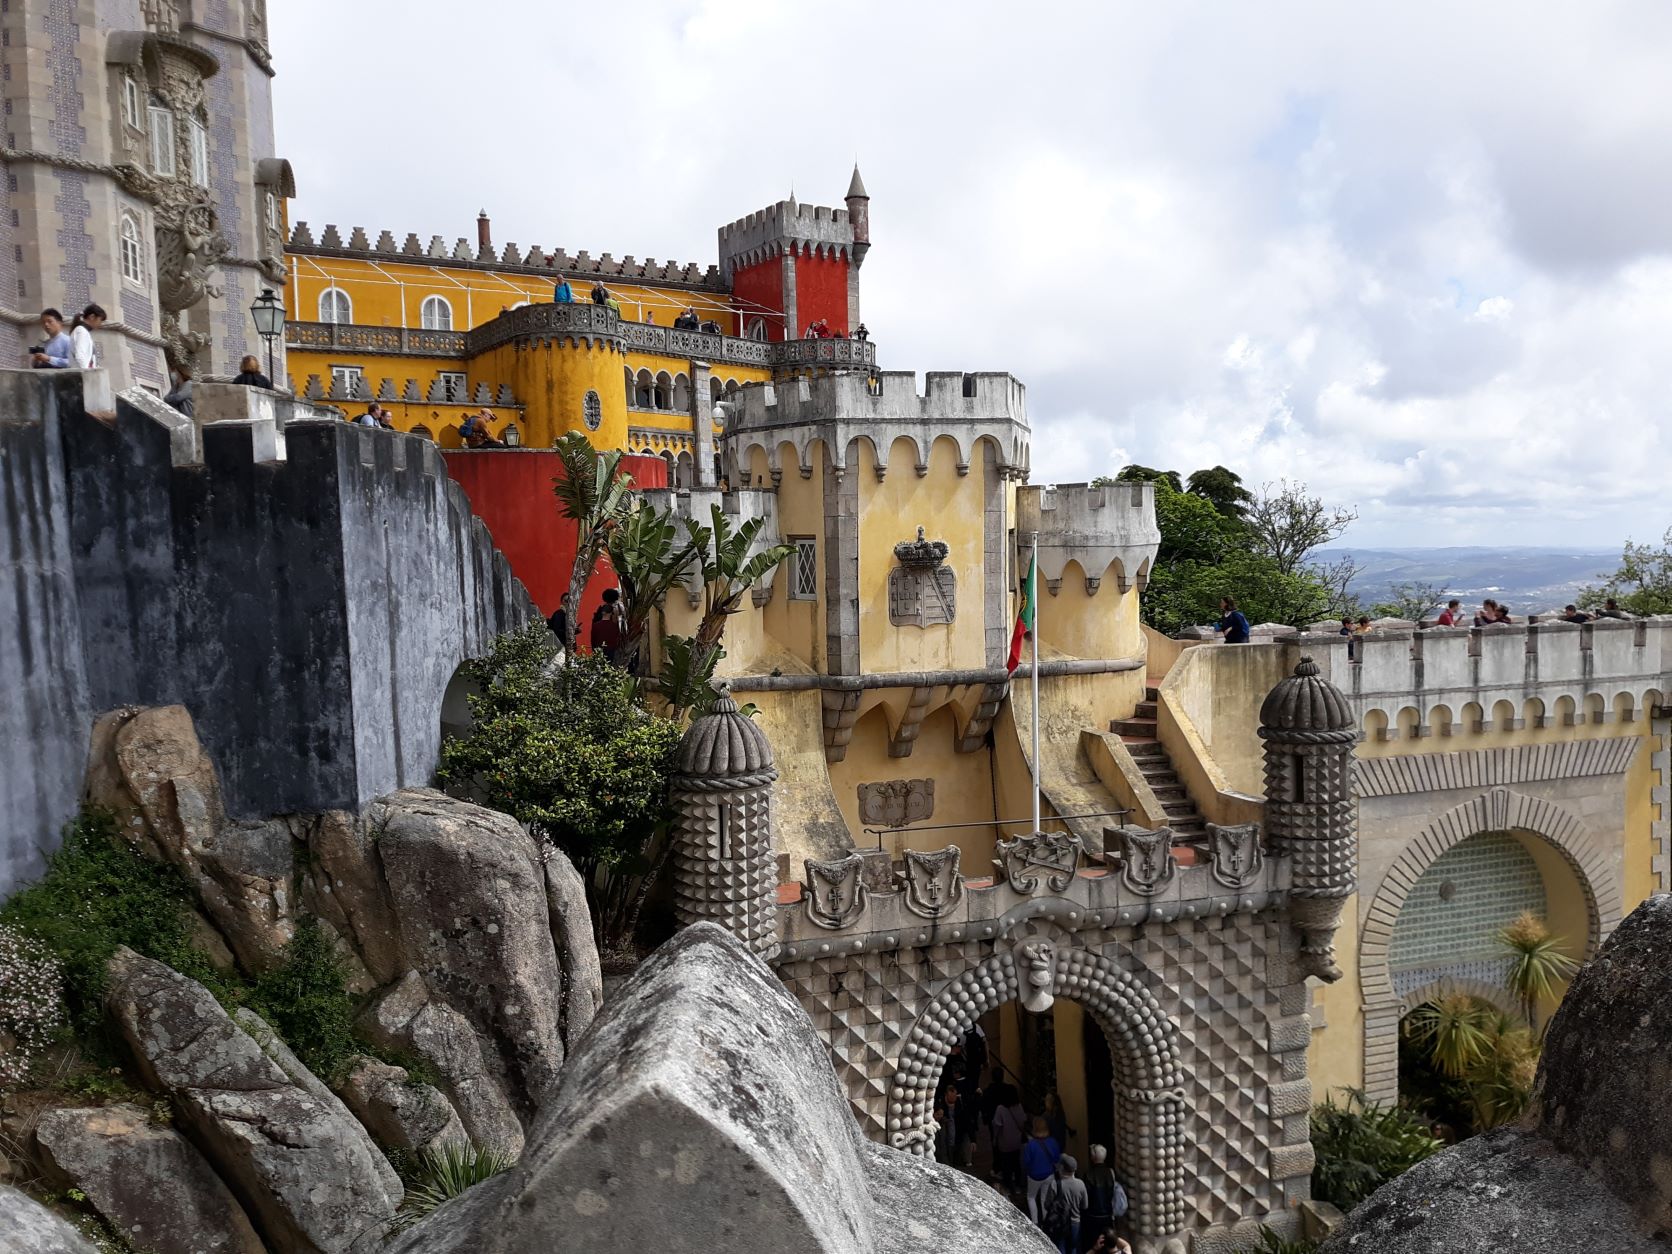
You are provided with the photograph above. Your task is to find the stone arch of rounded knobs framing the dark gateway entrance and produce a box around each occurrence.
[888,926,1185,1237]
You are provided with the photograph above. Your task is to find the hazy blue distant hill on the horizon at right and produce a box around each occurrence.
[1316,545,1620,614]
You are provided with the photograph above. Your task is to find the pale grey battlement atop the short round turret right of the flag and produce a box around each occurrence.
[1017,483,1160,595]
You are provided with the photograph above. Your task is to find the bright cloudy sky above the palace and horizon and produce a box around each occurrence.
[271,0,1672,547]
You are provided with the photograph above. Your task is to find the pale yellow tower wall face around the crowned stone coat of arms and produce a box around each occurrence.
[856,438,991,672]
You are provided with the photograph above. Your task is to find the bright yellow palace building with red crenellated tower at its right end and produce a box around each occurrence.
[281,169,876,485]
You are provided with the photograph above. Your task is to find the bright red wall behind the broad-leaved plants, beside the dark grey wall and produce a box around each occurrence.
[441,448,667,639]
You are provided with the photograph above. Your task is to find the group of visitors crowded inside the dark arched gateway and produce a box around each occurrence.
[935,1027,1130,1254]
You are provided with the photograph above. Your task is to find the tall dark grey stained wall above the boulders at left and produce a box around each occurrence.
[0,371,533,896]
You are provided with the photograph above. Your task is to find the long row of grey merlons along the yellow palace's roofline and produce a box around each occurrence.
[288,222,724,291]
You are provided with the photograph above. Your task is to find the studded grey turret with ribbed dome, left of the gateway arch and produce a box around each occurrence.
[672,692,777,958]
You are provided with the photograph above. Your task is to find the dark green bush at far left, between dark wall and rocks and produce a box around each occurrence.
[0,809,224,1038]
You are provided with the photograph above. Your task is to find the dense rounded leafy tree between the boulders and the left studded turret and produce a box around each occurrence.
[436,624,681,948]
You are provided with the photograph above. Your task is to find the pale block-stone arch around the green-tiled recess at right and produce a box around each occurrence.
[1359,788,1622,1104]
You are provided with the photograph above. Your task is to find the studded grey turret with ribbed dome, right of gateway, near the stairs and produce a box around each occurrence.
[1259,657,1359,981]
